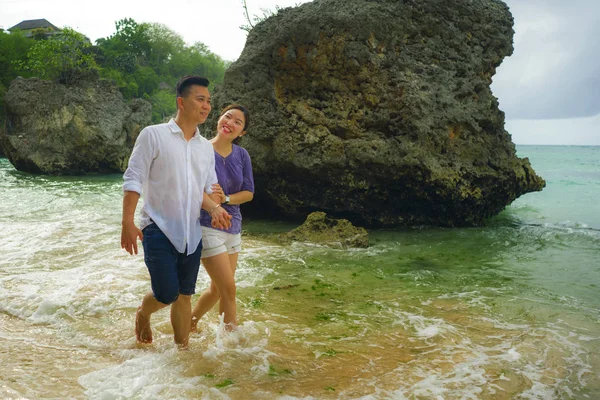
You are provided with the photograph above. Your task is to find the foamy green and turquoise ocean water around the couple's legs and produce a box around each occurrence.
[0,146,600,399]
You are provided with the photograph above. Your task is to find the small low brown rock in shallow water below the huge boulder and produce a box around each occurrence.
[278,212,369,248]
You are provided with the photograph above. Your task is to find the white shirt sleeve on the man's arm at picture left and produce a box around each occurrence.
[123,128,155,195]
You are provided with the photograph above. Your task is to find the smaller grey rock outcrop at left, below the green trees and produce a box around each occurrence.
[0,78,152,174]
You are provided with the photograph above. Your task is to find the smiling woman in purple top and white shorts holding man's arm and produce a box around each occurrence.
[192,104,254,331]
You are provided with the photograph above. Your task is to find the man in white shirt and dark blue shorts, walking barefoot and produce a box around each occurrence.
[121,76,231,347]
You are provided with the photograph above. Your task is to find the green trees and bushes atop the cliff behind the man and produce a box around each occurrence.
[0,19,228,122]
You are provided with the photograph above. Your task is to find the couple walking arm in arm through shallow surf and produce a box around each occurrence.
[121,76,254,347]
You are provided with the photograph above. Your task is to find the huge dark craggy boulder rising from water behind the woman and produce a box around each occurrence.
[213,0,545,226]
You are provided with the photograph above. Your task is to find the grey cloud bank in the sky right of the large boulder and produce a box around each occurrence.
[492,0,600,119]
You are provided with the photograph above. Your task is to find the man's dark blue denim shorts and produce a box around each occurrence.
[142,223,202,304]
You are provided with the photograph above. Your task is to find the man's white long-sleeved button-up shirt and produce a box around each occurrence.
[123,119,217,255]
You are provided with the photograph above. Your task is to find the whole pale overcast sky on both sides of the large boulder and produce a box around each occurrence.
[0,0,600,145]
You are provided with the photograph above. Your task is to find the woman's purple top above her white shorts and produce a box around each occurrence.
[200,144,254,234]
